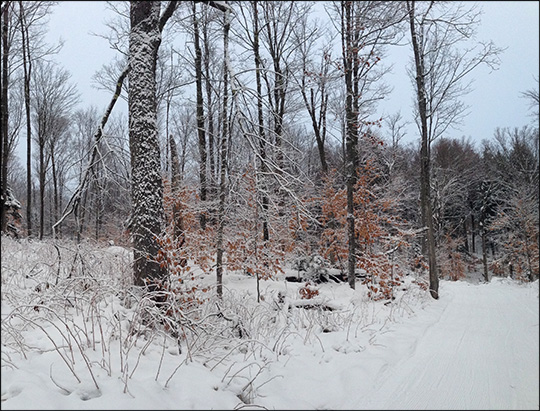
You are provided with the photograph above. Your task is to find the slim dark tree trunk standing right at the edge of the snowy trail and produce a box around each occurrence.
[407,1,439,299]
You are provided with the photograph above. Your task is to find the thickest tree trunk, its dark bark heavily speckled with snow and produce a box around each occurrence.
[128,1,166,286]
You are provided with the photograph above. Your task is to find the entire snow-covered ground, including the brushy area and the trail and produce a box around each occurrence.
[1,238,540,409]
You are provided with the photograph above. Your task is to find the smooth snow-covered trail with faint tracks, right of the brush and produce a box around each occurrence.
[362,280,539,409]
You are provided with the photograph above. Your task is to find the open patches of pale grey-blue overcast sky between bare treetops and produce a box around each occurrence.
[43,1,540,150]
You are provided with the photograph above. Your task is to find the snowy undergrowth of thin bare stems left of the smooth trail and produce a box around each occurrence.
[1,237,429,409]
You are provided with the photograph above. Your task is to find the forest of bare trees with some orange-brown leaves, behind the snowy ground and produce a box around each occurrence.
[0,1,540,299]
